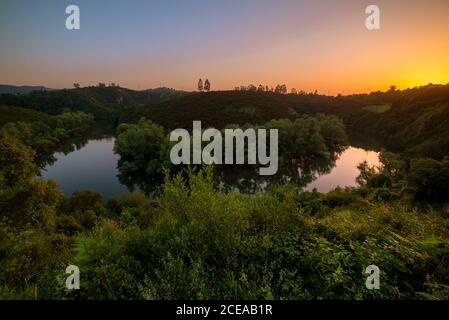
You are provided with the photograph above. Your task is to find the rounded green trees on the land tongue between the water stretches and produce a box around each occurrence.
[114,114,347,174]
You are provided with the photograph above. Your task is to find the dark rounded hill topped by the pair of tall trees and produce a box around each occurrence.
[121,91,297,128]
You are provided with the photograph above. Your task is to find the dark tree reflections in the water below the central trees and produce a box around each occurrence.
[118,148,346,196]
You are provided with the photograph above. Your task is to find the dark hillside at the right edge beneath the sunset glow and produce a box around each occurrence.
[346,85,449,160]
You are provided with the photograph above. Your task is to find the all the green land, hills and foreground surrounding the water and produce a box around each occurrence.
[0,85,449,300]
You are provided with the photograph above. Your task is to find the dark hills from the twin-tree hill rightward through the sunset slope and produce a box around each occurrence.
[120,85,449,158]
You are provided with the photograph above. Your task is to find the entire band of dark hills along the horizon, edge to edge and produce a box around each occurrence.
[0,84,449,158]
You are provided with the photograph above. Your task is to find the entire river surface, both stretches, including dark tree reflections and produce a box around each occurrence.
[42,137,379,199]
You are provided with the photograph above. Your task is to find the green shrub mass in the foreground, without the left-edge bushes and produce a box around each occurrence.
[58,170,449,299]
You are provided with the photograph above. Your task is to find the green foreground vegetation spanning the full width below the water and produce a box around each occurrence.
[0,131,449,299]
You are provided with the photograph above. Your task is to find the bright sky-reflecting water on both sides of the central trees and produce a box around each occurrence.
[42,138,379,199]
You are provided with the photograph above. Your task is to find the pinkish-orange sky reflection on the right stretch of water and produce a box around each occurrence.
[305,147,379,192]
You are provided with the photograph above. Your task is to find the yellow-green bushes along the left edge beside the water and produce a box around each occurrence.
[0,136,67,297]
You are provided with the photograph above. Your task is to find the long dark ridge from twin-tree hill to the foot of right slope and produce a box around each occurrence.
[120,91,384,128]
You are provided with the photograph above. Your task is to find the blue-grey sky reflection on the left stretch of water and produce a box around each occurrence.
[42,138,127,199]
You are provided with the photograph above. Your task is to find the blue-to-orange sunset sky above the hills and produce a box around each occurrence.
[0,0,449,94]
